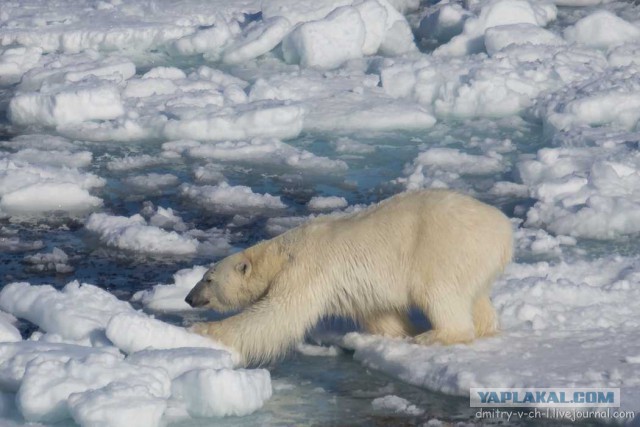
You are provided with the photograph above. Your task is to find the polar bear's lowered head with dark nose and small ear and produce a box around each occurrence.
[185,252,267,312]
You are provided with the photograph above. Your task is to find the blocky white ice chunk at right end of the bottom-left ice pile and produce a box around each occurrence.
[171,369,272,417]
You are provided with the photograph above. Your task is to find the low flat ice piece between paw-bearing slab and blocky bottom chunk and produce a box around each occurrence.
[127,347,234,379]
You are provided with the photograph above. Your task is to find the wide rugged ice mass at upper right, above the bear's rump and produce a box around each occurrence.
[380,41,609,119]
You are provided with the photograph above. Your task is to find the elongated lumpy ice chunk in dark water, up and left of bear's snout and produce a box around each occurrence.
[85,213,199,255]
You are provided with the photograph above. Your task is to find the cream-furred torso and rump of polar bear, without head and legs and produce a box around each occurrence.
[292,190,512,311]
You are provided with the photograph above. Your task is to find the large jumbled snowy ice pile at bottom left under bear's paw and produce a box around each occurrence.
[0,282,271,426]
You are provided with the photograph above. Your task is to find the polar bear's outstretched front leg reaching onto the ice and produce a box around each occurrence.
[191,285,324,365]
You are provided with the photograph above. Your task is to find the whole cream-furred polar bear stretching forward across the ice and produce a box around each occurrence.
[186,190,513,364]
